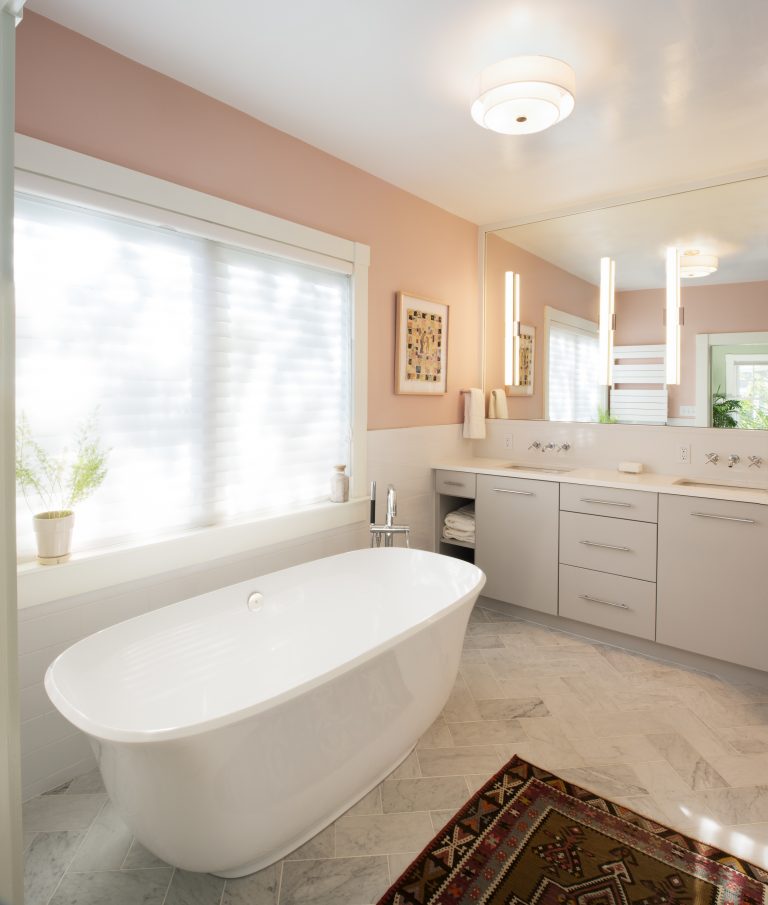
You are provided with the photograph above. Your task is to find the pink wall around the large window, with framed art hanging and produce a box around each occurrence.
[16,13,480,428]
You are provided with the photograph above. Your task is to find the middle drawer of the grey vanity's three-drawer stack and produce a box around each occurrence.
[560,512,656,581]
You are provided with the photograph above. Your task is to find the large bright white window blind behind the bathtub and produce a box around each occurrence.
[15,195,352,558]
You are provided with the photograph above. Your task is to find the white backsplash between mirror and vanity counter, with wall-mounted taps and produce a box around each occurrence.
[473,420,768,483]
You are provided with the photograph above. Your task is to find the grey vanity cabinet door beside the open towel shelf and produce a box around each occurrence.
[475,474,560,614]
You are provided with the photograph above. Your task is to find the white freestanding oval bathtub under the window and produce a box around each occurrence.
[45,548,485,877]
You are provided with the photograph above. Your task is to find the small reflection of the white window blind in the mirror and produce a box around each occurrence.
[547,320,600,421]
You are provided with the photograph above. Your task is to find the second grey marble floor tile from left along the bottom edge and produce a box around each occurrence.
[50,868,173,905]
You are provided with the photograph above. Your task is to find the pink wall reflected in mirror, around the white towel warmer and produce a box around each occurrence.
[615,281,768,418]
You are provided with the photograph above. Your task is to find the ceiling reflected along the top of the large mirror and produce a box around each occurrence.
[497,176,768,290]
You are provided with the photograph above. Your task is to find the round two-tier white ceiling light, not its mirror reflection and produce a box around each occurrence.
[471,56,576,135]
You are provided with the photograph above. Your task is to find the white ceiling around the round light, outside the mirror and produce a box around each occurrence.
[21,0,768,224]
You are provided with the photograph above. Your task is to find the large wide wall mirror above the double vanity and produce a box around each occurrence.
[484,176,768,429]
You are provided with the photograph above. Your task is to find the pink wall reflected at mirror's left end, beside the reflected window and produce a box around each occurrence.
[484,233,600,418]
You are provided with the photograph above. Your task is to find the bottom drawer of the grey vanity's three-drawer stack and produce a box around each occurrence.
[558,566,656,641]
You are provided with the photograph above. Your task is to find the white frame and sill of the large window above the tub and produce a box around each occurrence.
[15,135,370,608]
